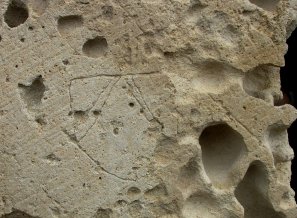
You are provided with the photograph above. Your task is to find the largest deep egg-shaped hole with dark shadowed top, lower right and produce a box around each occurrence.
[199,123,246,186]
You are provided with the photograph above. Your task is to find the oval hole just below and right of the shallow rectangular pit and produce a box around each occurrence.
[82,37,108,58]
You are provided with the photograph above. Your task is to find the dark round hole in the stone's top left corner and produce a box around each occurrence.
[4,0,29,28]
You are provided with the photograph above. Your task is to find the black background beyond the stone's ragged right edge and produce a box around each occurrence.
[280,26,297,200]
